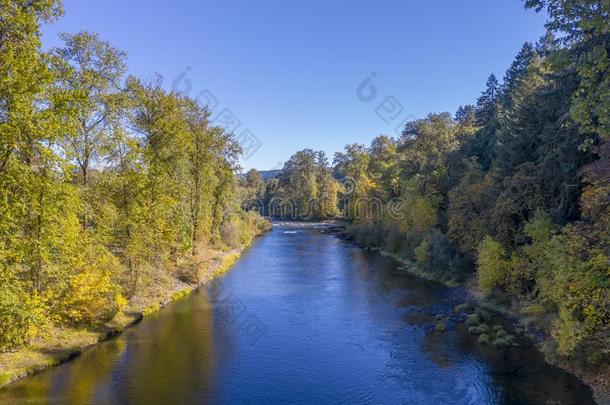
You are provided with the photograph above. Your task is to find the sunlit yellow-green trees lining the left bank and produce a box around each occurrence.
[0,0,266,351]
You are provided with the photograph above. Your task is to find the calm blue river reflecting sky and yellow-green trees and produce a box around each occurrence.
[0,226,592,405]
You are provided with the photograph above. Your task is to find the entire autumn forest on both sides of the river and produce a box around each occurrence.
[0,0,610,394]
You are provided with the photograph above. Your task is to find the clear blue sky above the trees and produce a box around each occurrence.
[43,0,545,169]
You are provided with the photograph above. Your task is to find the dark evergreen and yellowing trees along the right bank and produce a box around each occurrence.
[245,0,610,365]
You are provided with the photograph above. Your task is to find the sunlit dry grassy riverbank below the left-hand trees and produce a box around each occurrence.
[0,238,256,388]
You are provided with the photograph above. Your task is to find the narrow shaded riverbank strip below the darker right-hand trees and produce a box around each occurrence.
[333,231,610,405]
